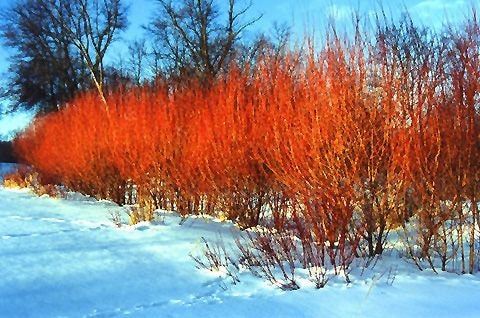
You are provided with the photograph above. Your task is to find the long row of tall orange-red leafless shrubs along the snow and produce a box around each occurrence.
[15,9,480,273]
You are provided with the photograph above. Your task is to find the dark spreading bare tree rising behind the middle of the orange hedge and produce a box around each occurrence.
[147,0,260,78]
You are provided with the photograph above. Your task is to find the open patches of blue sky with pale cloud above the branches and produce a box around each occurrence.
[0,0,474,139]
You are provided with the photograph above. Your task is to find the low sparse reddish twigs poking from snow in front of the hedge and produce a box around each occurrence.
[191,217,356,290]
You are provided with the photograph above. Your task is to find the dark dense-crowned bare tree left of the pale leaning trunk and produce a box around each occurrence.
[0,0,91,112]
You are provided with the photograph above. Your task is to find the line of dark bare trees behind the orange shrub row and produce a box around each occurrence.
[0,0,290,113]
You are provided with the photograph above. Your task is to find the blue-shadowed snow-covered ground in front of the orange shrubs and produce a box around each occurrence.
[0,166,480,317]
